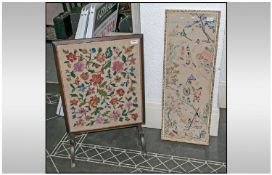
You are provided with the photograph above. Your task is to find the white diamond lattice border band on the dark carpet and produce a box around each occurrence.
[50,134,227,173]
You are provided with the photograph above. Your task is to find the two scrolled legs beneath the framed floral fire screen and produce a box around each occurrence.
[69,124,147,168]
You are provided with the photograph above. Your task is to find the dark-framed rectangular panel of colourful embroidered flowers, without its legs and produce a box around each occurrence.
[54,35,144,132]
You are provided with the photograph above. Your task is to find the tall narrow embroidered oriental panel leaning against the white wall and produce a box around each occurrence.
[161,10,220,145]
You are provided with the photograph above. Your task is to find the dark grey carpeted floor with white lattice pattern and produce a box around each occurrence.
[46,84,227,173]
